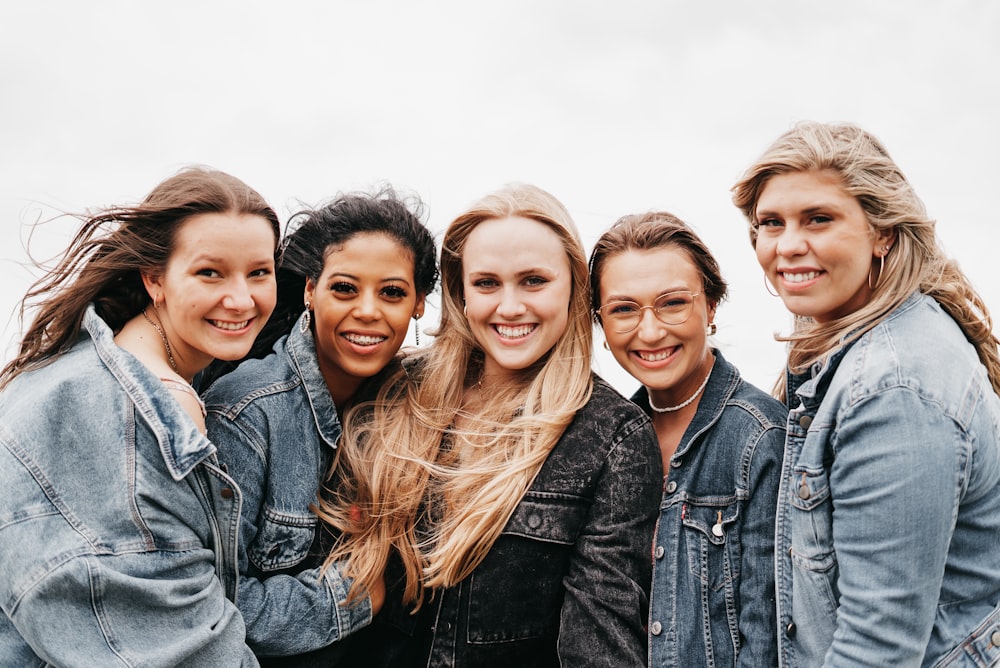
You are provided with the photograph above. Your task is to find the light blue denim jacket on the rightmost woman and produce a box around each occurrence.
[777,293,1000,668]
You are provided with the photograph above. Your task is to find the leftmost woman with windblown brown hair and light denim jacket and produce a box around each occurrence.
[0,169,279,667]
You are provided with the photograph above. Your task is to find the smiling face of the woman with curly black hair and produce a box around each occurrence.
[305,233,424,406]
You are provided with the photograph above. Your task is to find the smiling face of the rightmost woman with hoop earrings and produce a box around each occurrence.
[755,170,891,323]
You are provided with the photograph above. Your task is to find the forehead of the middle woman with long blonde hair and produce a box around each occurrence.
[462,216,569,273]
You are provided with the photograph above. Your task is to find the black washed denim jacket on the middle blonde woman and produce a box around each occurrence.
[341,377,663,668]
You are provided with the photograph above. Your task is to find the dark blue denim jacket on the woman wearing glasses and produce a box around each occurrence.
[632,350,788,668]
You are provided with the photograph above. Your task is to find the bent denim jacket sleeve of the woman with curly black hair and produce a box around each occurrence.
[207,411,372,656]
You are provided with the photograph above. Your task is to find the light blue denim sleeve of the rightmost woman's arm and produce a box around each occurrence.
[826,388,964,666]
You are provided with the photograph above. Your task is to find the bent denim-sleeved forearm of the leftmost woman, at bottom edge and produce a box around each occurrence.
[8,549,257,668]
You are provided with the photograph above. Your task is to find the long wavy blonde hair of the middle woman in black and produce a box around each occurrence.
[317,184,593,607]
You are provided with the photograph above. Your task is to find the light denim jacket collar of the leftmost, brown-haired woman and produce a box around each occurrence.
[83,304,215,481]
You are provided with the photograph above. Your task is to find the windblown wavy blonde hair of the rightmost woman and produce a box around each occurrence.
[732,122,1000,399]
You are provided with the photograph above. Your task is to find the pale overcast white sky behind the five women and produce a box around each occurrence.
[0,0,1000,393]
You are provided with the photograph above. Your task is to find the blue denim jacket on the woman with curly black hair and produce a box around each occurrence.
[204,316,372,661]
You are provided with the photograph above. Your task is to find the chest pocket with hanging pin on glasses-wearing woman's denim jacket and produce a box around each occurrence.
[681,500,740,591]
